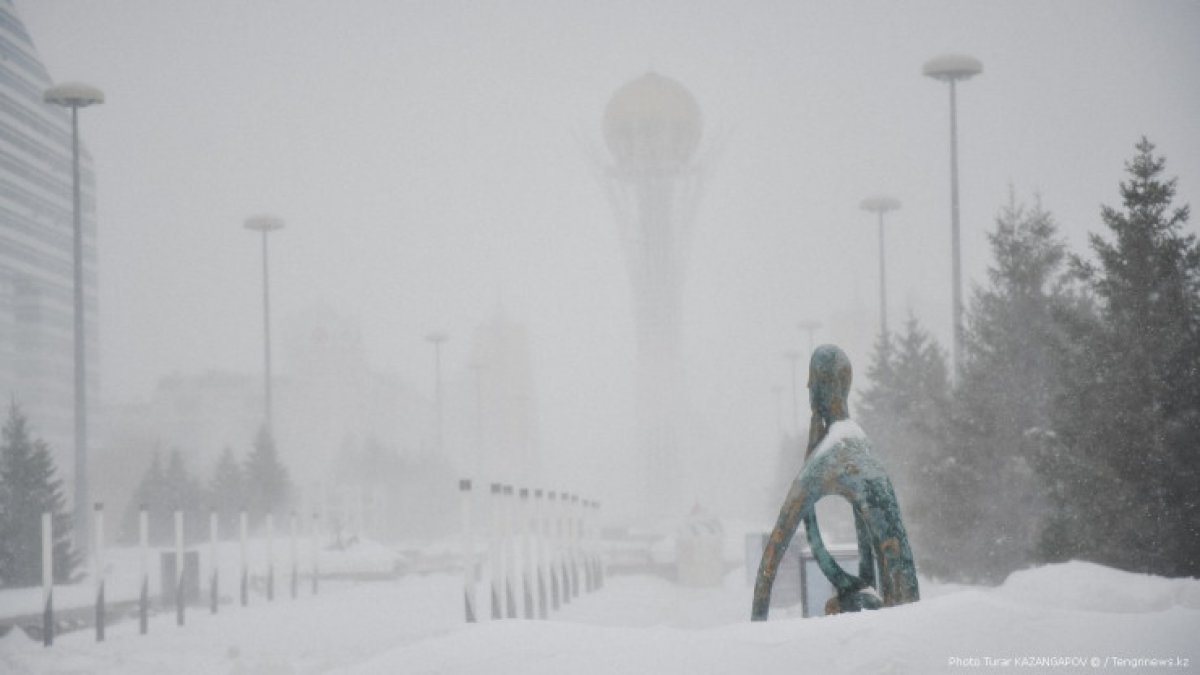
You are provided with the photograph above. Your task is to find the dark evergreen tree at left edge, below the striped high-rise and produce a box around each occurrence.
[0,401,79,587]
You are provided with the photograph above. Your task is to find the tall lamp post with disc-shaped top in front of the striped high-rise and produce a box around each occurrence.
[42,82,104,552]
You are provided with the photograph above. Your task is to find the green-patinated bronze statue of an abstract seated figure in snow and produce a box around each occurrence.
[750,345,919,621]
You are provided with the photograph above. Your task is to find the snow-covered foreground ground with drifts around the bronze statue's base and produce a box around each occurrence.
[0,562,1200,675]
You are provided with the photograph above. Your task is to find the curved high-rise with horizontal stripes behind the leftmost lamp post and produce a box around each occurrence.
[0,0,100,468]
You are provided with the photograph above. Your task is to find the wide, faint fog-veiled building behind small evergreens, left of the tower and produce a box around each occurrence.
[97,310,432,514]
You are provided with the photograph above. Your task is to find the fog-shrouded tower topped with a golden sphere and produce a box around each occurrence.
[604,72,702,515]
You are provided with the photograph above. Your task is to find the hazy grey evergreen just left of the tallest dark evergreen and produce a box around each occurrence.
[950,189,1074,581]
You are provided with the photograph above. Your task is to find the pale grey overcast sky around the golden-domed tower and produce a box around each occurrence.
[17,0,1200,506]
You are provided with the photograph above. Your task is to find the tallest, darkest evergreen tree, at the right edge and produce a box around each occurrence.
[1067,138,1200,575]
